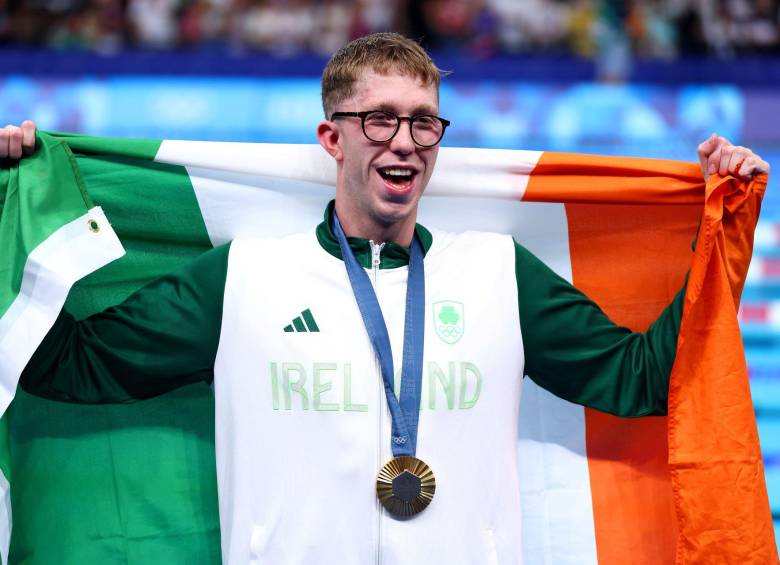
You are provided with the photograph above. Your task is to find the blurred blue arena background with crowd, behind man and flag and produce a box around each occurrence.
[0,0,780,548]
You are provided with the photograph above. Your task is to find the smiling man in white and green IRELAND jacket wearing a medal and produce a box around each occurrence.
[0,34,769,564]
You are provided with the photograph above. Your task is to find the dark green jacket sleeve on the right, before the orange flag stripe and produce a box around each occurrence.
[515,243,684,417]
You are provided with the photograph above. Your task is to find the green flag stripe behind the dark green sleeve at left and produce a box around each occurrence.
[6,135,220,565]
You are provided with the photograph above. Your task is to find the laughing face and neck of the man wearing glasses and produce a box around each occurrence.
[317,65,442,246]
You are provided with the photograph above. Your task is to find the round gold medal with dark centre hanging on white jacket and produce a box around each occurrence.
[376,456,436,516]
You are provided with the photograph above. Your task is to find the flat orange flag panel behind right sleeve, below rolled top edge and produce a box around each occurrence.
[566,199,699,565]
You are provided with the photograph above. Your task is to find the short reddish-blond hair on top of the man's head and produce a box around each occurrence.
[322,32,443,119]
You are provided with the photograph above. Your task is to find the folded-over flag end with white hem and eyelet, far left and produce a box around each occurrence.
[0,135,123,563]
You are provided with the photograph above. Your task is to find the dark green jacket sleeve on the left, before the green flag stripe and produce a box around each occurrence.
[20,245,229,403]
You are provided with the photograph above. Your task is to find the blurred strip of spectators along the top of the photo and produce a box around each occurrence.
[0,0,780,58]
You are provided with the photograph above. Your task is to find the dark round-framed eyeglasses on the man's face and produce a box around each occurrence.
[330,110,450,147]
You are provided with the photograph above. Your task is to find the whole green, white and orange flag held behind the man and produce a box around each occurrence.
[0,130,777,565]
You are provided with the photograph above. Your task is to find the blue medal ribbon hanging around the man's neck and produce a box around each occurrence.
[333,212,425,457]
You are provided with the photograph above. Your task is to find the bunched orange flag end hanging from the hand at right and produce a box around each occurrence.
[669,175,778,565]
